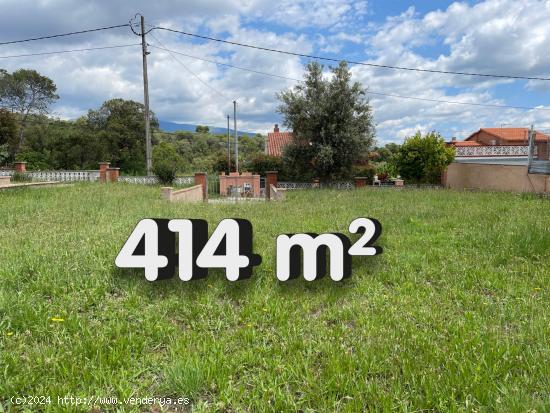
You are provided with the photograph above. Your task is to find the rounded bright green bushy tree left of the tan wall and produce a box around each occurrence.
[393,131,454,183]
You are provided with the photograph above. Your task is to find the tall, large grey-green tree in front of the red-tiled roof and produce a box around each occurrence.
[277,62,374,178]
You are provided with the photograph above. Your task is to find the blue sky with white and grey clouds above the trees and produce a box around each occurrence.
[0,0,550,143]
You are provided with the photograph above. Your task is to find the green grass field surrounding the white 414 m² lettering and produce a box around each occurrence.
[0,184,550,412]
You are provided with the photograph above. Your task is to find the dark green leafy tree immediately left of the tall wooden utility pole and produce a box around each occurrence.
[87,99,158,173]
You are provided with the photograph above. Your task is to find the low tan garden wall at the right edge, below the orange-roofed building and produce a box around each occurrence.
[444,162,550,193]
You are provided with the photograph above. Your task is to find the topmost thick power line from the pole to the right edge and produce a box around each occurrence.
[154,26,550,81]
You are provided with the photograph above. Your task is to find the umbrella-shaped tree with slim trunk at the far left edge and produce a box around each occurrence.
[0,69,59,152]
